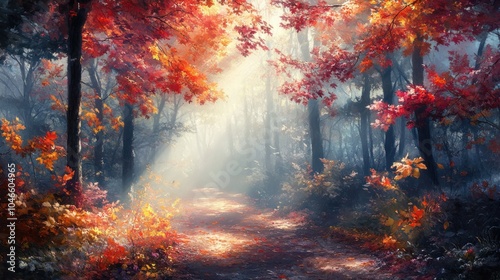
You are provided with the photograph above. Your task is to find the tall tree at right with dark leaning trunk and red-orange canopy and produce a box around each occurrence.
[274,0,499,184]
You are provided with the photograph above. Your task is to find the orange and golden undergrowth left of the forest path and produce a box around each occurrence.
[2,176,180,279]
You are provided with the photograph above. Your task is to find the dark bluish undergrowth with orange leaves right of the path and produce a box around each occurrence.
[282,157,500,279]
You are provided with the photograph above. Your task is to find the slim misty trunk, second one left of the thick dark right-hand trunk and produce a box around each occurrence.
[359,73,371,176]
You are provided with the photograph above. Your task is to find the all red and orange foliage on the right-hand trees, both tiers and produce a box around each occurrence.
[273,1,500,136]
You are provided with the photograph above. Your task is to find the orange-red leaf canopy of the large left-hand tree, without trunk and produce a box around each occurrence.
[65,0,271,117]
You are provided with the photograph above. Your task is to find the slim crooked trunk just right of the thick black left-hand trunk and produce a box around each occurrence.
[88,59,104,187]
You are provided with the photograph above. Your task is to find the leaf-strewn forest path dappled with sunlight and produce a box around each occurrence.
[173,189,395,280]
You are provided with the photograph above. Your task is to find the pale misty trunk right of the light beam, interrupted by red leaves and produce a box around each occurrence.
[297,29,324,173]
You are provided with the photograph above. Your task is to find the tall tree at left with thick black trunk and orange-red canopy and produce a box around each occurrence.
[29,0,270,205]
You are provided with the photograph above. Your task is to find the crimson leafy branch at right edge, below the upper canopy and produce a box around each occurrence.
[369,47,500,130]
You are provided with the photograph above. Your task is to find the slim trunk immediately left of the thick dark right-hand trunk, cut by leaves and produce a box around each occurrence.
[380,66,396,171]
